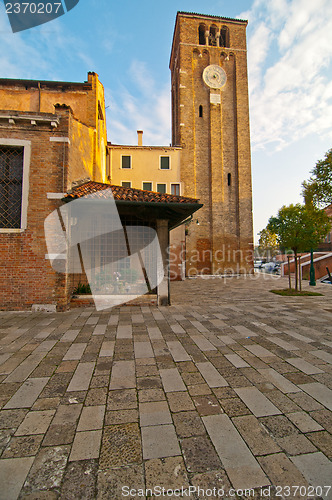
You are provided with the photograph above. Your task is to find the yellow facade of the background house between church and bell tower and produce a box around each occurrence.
[108,144,183,195]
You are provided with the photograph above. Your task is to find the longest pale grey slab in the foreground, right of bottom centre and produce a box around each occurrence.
[202,415,270,489]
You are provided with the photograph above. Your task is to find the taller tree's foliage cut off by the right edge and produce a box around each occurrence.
[302,149,332,208]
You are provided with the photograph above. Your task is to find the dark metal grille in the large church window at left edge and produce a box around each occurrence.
[0,145,23,229]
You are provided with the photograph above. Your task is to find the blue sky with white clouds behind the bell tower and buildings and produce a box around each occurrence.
[0,0,332,243]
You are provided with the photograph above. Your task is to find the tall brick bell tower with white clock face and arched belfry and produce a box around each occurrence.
[170,12,253,275]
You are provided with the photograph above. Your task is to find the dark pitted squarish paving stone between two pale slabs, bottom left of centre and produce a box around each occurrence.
[99,423,140,469]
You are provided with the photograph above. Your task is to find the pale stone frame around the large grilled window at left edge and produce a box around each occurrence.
[0,137,31,234]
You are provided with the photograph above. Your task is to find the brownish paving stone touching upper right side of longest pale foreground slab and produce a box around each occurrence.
[232,415,280,455]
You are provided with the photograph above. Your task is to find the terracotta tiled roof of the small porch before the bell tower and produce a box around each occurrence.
[65,181,199,203]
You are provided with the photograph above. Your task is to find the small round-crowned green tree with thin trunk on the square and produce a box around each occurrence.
[266,203,331,290]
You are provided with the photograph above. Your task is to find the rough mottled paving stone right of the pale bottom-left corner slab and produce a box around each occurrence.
[22,446,70,497]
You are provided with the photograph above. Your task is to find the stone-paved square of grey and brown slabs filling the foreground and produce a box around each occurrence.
[0,275,332,500]
